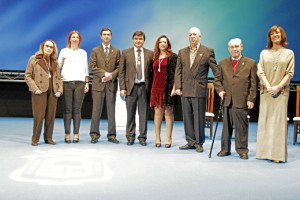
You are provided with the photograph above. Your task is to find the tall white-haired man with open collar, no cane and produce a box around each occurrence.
[175,27,221,152]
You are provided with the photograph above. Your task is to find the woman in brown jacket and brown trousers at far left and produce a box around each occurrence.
[25,40,63,146]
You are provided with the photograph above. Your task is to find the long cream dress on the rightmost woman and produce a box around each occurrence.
[256,48,294,162]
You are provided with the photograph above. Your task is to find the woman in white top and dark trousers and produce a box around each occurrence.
[58,31,89,143]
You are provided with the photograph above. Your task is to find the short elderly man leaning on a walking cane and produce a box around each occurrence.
[217,38,257,159]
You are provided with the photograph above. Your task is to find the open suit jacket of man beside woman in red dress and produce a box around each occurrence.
[119,47,153,95]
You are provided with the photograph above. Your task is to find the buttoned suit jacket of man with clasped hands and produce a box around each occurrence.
[89,44,120,92]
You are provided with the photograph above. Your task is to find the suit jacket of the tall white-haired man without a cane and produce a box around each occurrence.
[175,45,221,97]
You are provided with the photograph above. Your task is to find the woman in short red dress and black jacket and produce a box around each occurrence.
[150,35,177,148]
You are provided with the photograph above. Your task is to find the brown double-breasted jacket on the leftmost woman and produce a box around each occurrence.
[24,55,63,93]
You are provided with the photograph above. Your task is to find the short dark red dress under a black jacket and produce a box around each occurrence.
[150,58,168,108]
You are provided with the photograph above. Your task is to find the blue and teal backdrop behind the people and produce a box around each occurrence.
[0,0,300,81]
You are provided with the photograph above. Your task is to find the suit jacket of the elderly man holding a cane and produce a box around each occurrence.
[217,57,257,108]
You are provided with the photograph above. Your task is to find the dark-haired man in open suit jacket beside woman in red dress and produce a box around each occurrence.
[119,31,153,146]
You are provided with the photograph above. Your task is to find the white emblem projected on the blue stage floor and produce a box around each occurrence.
[10,149,114,185]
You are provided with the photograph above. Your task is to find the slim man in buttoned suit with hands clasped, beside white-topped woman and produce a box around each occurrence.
[89,28,120,144]
